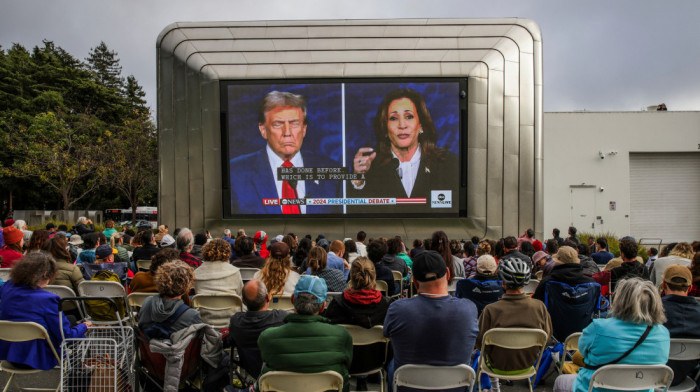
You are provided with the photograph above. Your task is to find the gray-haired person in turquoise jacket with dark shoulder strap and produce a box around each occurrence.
[553,277,671,392]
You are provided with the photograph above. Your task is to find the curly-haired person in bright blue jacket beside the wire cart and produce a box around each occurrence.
[0,251,92,370]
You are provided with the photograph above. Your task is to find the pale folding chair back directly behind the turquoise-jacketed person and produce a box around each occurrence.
[588,365,673,392]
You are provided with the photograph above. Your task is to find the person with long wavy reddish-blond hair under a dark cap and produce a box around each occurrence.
[253,242,300,296]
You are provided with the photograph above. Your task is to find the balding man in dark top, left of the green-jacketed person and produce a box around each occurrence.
[228,279,289,378]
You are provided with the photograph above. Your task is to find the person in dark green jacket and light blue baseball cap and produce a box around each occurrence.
[258,278,352,392]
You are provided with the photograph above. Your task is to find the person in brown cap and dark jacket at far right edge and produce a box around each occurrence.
[661,264,700,386]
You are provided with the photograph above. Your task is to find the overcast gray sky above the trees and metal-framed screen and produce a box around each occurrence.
[0,0,700,111]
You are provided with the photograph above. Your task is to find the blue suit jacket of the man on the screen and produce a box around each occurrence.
[229,148,342,215]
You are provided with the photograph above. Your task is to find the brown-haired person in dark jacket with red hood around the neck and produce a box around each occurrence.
[323,256,390,328]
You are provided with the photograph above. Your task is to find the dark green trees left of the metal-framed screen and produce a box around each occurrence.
[0,41,157,217]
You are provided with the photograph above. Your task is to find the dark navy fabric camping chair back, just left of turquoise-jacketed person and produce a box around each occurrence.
[544,281,600,342]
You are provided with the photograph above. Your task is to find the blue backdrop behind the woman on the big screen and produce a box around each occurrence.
[345,82,459,164]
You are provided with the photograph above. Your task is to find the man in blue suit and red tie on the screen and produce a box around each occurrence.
[230,91,341,215]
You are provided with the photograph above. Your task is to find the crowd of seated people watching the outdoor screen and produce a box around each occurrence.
[0,219,700,391]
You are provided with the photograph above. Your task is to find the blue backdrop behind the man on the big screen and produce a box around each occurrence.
[228,83,343,166]
